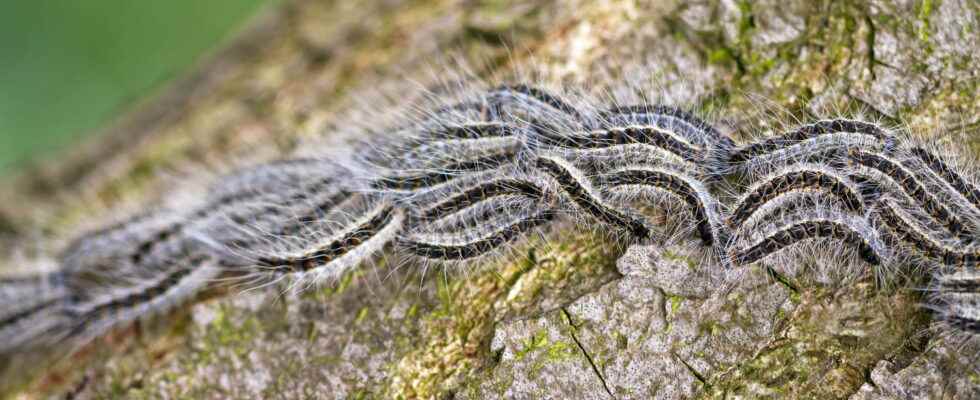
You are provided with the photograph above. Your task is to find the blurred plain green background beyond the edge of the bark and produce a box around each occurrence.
[0,0,274,174]
